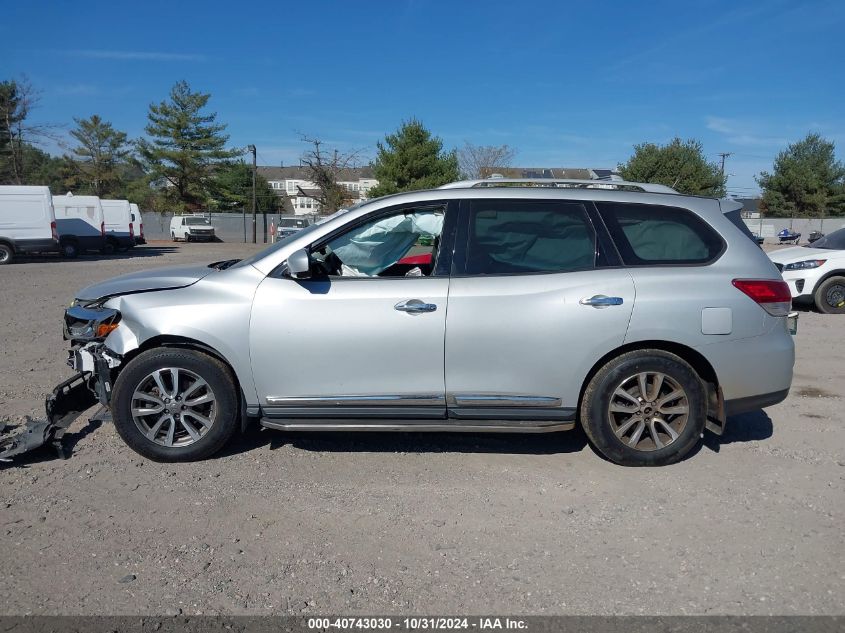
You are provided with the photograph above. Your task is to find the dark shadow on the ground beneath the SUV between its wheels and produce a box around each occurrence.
[216,424,587,457]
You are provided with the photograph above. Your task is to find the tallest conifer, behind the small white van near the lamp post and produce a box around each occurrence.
[138,81,241,210]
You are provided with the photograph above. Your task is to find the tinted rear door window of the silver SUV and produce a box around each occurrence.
[466,200,596,275]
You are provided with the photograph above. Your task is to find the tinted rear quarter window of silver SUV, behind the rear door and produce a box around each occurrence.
[596,202,724,266]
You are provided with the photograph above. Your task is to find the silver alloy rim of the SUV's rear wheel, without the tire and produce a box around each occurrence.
[607,371,690,451]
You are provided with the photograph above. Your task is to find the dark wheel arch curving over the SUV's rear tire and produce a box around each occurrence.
[578,340,726,434]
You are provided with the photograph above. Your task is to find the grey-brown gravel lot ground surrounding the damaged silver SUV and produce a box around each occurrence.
[0,243,845,615]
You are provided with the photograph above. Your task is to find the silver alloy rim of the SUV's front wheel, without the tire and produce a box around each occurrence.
[131,367,217,448]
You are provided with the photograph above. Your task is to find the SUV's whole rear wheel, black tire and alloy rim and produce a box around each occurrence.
[581,350,707,466]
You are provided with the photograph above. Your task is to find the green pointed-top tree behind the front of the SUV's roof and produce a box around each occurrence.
[369,119,460,198]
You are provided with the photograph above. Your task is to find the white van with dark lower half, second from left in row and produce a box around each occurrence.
[53,193,106,257]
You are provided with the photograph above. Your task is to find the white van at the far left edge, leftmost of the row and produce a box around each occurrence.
[0,185,59,264]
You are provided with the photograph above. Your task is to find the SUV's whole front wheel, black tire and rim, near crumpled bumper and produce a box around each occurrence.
[111,348,238,462]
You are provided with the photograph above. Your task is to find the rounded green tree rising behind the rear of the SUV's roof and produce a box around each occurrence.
[619,137,726,197]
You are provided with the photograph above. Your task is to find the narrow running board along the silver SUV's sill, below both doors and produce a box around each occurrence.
[260,418,575,433]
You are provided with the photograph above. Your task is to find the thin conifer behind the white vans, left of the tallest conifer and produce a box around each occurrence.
[67,114,131,198]
